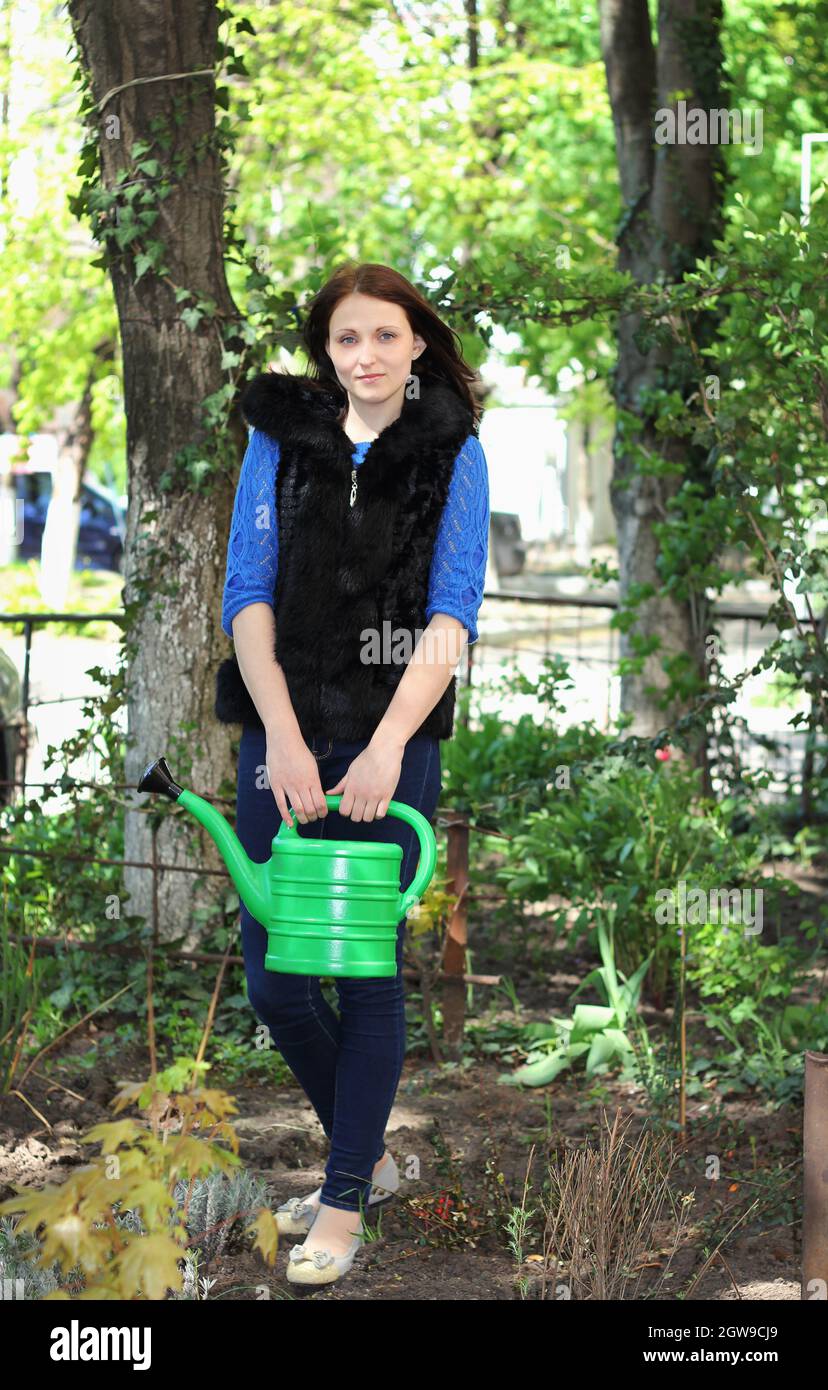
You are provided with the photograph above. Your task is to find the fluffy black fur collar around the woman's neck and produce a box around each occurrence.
[242,371,472,480]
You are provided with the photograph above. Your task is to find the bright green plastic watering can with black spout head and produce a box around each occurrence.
[138,758,438,979]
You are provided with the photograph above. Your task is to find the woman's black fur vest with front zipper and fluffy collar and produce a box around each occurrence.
[215,373,477,742]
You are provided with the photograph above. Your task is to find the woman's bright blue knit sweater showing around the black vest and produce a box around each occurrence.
[221,430,489,644]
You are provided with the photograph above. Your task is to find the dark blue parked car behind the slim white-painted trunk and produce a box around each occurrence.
[13,464,126,573]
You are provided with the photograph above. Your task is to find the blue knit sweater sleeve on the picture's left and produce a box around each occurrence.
[221,430,279,638]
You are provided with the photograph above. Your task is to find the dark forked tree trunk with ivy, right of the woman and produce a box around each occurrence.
[600,0,722,737]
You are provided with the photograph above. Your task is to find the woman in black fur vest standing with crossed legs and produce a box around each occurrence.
[215,264,489,1284]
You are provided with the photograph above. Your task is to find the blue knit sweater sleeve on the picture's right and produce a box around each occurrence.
[425,435,489,645]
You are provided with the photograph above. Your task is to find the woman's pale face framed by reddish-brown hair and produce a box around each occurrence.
[325,293,427,404]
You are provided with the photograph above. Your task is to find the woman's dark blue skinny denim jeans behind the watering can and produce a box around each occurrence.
[236,724,442,1211]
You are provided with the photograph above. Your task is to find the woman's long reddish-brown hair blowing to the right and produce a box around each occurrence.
[301,261,481,425]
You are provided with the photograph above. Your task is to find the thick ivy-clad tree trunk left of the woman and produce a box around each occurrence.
[69,0,245,944]
